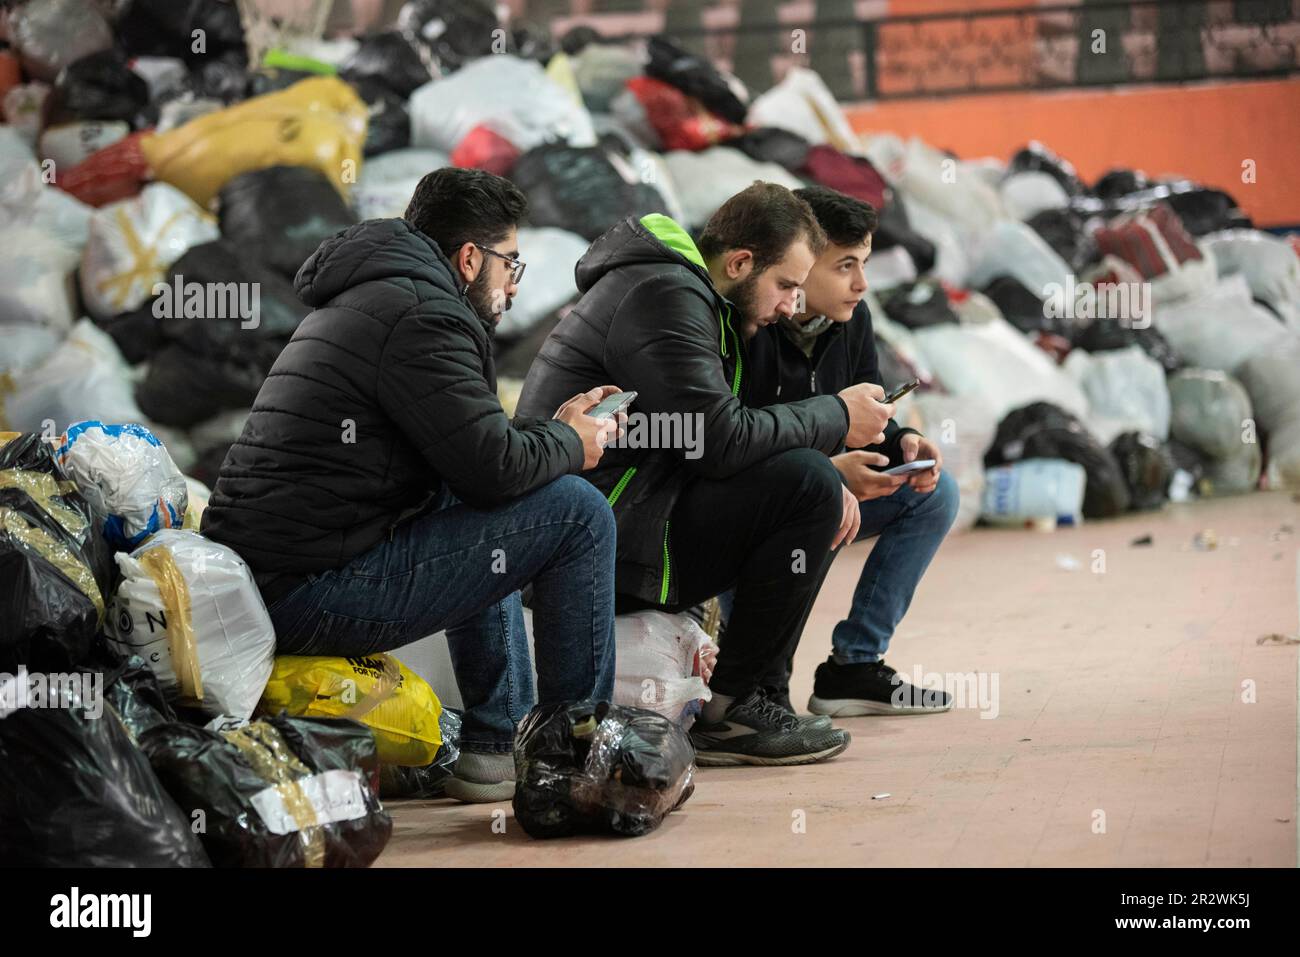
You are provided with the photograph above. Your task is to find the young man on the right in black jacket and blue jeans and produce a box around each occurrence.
[750,186,958,716]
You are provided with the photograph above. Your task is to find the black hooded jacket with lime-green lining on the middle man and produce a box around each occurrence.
[517,213,849,605]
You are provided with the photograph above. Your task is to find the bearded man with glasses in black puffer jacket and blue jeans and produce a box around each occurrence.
[203,168,616,801]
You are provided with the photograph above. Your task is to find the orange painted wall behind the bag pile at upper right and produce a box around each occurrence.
[846,78,1300,226]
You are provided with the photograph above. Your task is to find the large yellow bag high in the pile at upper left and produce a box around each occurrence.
[140,77,368,207]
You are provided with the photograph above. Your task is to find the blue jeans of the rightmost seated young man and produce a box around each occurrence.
[719,471,959,688]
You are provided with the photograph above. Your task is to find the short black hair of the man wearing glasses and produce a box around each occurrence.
[403,166,528,259]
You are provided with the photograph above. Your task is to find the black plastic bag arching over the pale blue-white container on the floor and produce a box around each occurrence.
[984,402,1130,519]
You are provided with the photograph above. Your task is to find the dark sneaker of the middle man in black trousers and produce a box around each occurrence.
[690,690,852,767]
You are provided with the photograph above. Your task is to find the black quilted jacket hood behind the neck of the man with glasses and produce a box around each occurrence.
[294,220,460,308]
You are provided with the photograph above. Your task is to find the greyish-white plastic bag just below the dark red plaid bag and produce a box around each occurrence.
[1152,273,1287,372]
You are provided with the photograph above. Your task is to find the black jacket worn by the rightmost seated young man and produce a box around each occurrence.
[749,300,919,465]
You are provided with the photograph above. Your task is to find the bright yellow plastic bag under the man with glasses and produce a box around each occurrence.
[257,654,442,767]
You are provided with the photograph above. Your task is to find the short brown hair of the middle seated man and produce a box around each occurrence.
[696,179,826,273]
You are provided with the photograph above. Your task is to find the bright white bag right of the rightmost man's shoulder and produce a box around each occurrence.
[913,319,1088,421]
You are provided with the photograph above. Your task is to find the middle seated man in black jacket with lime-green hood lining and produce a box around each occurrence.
[519,183,893,765]
